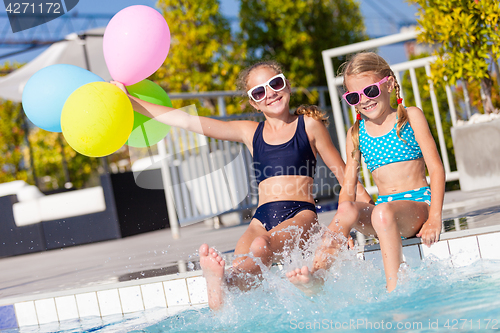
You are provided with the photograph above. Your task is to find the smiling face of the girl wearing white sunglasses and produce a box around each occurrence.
[247,66,290,115]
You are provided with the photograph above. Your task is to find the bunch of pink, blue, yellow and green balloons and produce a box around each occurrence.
[22,5,172,157]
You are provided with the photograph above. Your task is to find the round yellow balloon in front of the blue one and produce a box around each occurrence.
[61,82,134,157]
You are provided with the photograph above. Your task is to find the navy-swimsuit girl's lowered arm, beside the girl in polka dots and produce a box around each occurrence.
[306,117,372,202]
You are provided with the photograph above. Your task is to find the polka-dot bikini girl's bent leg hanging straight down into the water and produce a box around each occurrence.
[372,200,429,292]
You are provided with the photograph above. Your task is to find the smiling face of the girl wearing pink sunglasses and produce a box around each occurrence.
[345,72,394,119]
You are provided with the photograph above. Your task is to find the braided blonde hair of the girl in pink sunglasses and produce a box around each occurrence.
[339,52,408,158]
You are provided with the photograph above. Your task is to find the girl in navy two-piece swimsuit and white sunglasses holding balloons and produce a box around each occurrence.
[114,61,371,309]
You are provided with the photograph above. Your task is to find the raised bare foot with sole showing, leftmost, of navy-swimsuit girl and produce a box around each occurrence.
[198,244,226,310]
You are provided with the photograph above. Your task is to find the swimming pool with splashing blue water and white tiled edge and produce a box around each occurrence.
[0,206,500,333]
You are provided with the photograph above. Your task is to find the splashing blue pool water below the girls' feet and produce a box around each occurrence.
[12,251,500,333]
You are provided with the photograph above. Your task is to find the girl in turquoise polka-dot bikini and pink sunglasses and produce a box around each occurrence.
[287,52,445,292]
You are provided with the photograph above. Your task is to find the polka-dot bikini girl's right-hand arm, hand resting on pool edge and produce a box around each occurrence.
[407,107,445,246]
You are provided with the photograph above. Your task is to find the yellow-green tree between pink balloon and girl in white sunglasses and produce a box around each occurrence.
[151,0,246,115]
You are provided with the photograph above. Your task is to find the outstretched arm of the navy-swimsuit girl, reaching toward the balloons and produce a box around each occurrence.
[111,81,257,147]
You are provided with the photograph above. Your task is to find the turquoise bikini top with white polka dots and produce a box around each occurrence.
[359,119,423,172]
